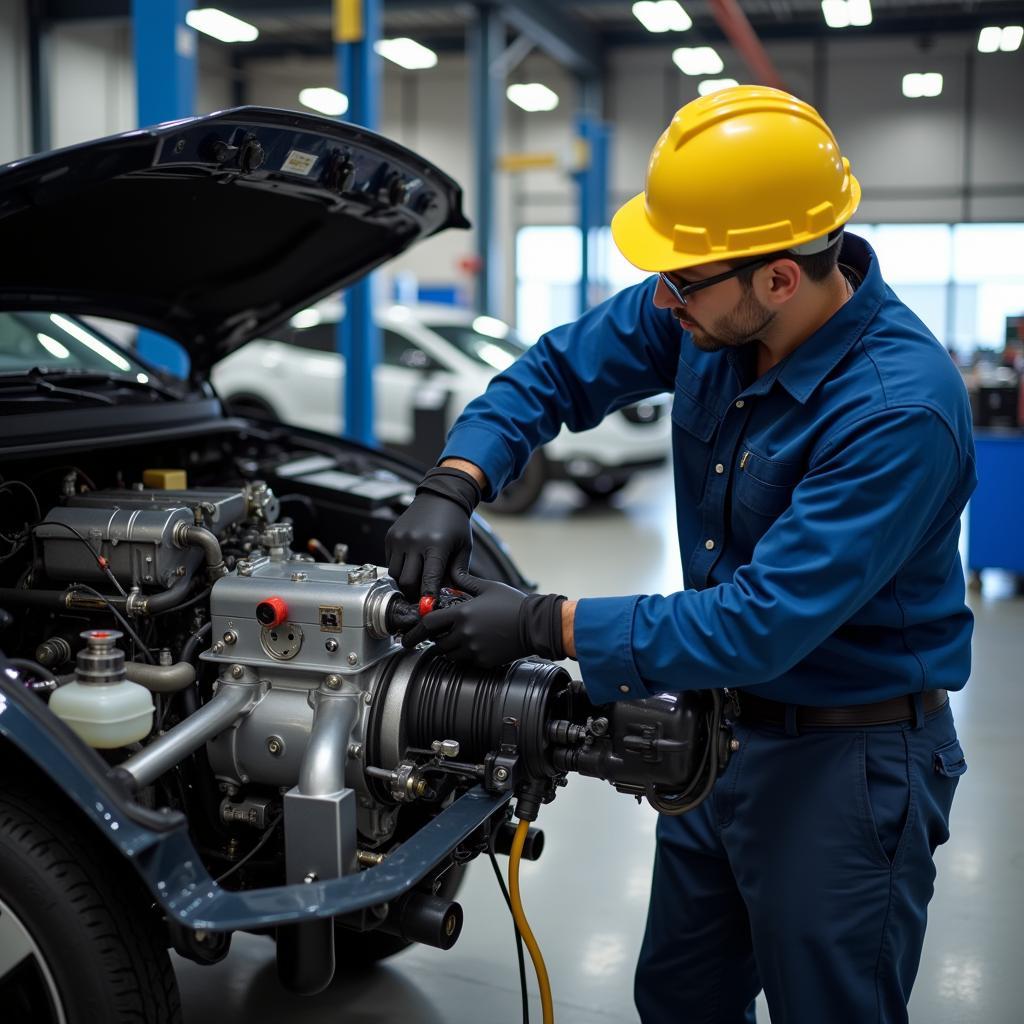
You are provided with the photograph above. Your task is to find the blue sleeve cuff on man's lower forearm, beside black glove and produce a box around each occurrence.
[573,595,650,703]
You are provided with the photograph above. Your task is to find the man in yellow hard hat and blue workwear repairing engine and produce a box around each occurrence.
[388,86,976,1024]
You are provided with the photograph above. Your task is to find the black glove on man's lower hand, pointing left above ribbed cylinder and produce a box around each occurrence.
[402,572,565,669]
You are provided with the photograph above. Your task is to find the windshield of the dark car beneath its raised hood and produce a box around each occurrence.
[0,312,148,383]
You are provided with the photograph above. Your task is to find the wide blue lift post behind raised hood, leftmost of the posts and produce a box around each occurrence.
[132,0,196,377]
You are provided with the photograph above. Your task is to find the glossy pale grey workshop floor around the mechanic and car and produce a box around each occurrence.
[176,473,1024,1024]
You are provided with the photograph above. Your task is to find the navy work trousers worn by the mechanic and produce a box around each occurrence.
[635,705,966,1024]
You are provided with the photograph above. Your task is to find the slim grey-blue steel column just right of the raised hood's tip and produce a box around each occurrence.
[467,4,505,315]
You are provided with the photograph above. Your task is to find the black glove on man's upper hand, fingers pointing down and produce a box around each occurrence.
[384,466,482,602]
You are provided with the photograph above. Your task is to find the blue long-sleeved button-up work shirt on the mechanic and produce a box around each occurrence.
[442,234,977,706]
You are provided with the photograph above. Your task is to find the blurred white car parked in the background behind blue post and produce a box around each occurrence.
[212,300,671,512]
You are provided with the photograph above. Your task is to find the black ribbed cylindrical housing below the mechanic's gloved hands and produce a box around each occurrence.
[406,656,568,778]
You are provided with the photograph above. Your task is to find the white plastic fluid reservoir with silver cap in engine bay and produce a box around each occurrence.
[50,630,153,750]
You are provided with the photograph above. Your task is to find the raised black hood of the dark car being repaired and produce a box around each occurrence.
[0,106,469,376]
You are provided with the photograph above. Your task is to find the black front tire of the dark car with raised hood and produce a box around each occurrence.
[0,792,181,1024]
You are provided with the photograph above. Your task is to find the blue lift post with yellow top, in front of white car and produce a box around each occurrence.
[334,0,380,444]
